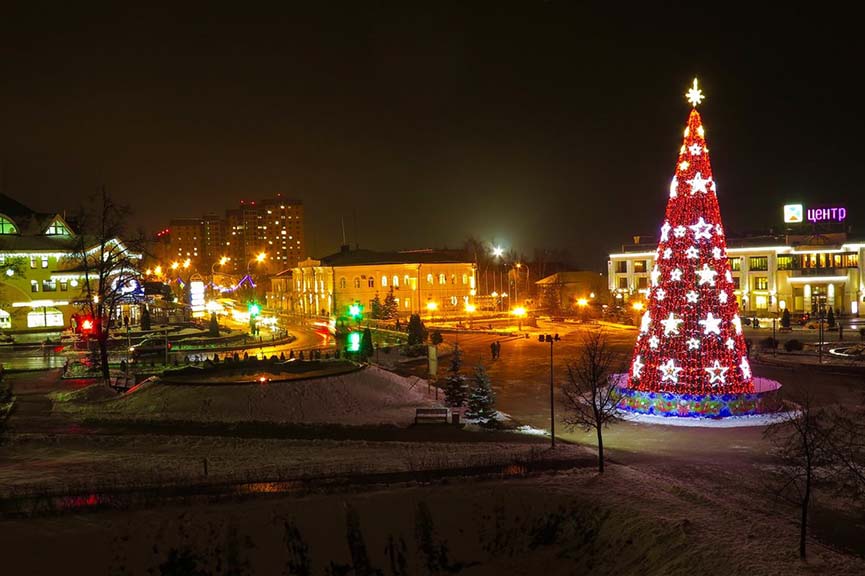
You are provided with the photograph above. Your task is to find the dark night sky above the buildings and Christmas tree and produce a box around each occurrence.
[0,1,865,268]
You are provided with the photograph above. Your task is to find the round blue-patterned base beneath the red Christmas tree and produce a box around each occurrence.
[614,374,787,426]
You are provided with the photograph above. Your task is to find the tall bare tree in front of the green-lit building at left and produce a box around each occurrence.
[71,188,140,383]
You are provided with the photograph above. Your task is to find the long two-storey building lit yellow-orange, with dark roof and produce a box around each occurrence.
[267,247,476,317]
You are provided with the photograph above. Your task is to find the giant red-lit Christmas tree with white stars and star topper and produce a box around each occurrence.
[628,80,754,395]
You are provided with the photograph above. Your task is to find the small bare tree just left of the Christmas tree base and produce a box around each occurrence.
[562,330,624,473]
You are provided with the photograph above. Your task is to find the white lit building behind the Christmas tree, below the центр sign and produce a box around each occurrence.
[608,232,865,316]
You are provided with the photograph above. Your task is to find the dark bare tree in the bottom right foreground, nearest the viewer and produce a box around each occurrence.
[763,395,832,560]
